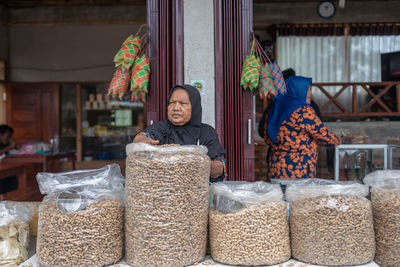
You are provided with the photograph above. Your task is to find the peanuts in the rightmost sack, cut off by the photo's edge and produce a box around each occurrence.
[371,188,400,267]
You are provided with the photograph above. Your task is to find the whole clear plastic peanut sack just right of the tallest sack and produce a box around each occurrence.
[209,182,291,266]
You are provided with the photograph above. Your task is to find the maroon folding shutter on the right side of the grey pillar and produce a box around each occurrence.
[214,0,255,181]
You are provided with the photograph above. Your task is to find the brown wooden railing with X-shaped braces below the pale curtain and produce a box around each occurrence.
[312,81,400,117]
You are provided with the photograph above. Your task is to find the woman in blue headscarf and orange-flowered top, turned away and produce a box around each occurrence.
[264,76,340,179]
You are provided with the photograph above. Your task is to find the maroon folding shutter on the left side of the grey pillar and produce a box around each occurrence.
[146,0,184,125]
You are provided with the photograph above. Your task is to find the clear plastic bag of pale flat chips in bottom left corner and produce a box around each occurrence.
[0,201,33,267]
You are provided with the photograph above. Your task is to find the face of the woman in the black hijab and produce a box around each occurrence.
[168,89,192,126]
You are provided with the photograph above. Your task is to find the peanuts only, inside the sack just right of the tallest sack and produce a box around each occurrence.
[209,201,290,266]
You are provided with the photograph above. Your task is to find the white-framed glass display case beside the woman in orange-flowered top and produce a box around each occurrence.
[335,144,400,181]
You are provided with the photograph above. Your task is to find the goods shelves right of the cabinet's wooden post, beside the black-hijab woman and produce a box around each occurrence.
[77,83,145,161]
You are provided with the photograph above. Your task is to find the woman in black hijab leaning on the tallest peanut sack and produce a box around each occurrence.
[133,85,225,182]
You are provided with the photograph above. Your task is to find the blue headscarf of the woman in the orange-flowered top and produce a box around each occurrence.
[268,76,312,144]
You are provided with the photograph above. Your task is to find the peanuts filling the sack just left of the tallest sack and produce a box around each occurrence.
[37,199,124,267]
